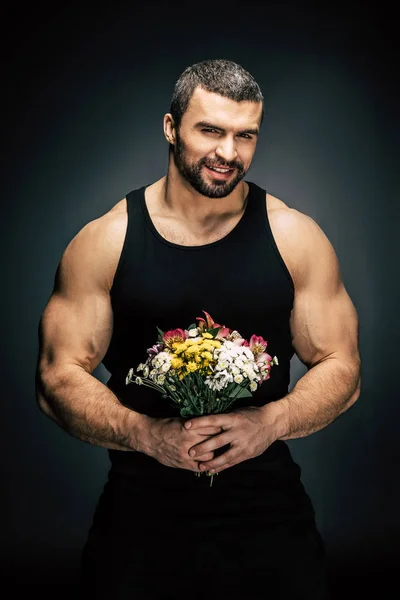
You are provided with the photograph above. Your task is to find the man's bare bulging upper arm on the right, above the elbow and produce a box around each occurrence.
[290,219,359,368]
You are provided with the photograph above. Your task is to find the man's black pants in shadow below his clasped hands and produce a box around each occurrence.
[80,470,330,600]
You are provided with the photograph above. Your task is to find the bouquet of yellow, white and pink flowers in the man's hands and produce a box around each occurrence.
[126,311,279,485]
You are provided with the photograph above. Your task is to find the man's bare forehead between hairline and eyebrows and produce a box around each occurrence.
[182,87,262,128]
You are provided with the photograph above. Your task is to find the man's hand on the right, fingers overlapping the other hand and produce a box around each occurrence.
[184,405,277,473]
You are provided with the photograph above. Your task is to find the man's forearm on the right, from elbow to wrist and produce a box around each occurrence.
[264,357,361,440]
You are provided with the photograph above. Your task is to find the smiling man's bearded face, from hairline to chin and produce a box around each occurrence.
[173,88,262,198]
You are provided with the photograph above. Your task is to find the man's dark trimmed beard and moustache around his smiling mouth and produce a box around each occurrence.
[172,132,247,198]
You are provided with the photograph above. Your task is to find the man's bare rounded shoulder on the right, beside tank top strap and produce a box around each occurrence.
[266,194,339,288]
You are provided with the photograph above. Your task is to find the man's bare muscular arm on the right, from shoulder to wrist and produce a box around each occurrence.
[264,210,361,440]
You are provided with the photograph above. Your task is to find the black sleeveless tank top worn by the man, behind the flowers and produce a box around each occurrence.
[103,182,300,480]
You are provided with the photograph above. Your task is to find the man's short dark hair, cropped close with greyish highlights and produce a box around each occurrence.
[170,59,264,130]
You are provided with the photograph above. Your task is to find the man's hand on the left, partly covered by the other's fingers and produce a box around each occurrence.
[141,417,221,472]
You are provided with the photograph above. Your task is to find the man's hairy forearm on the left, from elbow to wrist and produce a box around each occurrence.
[36,365,148,451]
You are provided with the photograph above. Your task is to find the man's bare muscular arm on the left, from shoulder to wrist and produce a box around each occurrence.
[36,211,147,451]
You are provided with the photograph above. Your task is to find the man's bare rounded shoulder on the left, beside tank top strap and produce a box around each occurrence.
[58,198,128,290]
